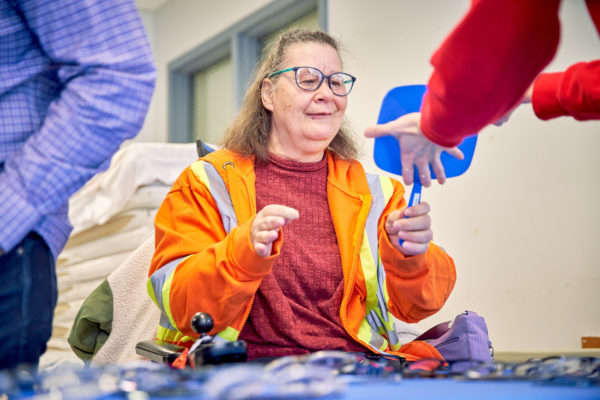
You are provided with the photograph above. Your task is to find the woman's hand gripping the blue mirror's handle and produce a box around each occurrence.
[385,202,433,256]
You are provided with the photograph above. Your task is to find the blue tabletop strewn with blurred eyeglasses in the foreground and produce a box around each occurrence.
[7,363,600,400]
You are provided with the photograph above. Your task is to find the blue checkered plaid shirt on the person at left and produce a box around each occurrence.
[0,0,156,257]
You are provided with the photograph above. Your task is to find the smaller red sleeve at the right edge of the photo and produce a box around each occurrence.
[531,60,600,121]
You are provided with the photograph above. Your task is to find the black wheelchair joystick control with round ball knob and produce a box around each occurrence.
[189,312,248,367]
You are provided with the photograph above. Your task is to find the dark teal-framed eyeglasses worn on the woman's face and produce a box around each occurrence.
[267,67,356,96]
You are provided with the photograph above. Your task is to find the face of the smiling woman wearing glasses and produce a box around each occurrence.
[261,42,348,162]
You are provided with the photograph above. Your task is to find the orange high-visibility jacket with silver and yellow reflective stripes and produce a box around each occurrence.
[148,150,456,359]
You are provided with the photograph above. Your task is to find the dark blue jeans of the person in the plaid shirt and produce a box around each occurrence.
[0,233,58,369]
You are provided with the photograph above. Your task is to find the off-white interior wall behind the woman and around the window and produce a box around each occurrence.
[138,0,600,351]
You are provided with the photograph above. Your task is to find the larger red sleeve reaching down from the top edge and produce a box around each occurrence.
[421,0,560,147]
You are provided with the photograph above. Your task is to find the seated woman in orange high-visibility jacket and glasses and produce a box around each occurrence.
[148,30,456,360]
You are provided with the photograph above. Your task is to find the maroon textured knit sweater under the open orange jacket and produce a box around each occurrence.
[240,156,365,359]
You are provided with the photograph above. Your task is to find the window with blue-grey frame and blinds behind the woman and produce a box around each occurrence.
[169,0,327,144]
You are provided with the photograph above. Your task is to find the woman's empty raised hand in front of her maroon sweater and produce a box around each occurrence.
[250,204,300,257]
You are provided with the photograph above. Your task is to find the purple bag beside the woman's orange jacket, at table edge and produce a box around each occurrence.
[415,311,494,372]
